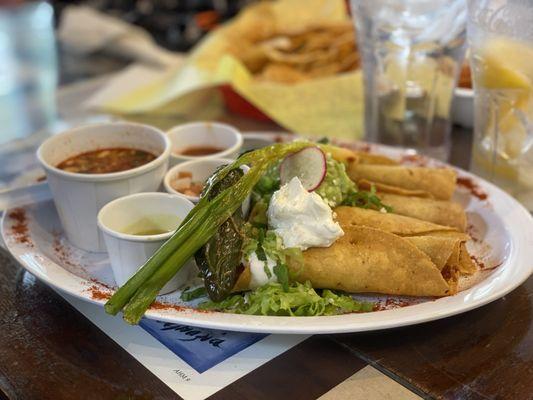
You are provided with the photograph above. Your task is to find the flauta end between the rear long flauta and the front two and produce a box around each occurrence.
[378,193,466,232]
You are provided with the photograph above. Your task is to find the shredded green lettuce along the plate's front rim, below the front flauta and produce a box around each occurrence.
[199,282,374,317]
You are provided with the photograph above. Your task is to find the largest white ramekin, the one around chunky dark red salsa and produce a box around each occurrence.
[37,122,171,252]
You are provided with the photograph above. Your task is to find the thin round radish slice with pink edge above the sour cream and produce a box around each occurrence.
[279,147,327,192]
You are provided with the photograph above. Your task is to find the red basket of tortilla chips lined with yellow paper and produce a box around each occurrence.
[100,0,363,139]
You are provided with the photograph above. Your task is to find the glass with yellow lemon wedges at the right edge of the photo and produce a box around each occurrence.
[468,0,533,210]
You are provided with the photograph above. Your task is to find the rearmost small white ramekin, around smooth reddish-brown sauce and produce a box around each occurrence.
[167,122,243,165]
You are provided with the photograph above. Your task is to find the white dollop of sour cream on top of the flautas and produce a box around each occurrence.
[267,177,344,250]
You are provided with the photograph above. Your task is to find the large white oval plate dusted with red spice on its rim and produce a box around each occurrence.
[2,145,533,334]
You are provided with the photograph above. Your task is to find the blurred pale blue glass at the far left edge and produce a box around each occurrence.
[0,1,57,144]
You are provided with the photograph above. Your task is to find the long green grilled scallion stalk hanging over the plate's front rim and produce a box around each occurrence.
[105,142,312,324]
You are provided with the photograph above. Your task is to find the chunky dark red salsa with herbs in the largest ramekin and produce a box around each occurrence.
[57,147,156,174]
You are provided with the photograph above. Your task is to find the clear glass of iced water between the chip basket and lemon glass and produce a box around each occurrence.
[351,0,466,160]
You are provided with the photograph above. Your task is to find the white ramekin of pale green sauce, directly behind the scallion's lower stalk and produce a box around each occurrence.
[98,193,197,294]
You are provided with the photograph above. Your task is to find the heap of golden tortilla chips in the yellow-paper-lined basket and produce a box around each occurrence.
[234,19,360,84]
